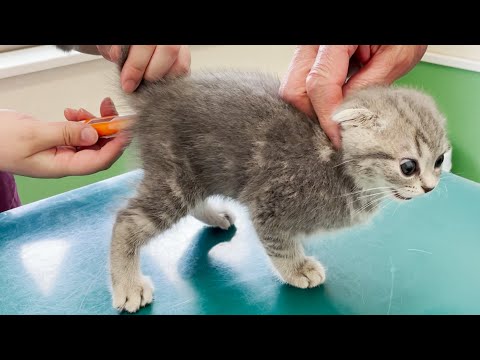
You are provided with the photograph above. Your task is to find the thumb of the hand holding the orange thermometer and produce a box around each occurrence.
[34,121,98,151]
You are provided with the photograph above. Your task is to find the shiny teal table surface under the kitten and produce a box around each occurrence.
[0,171,480,315]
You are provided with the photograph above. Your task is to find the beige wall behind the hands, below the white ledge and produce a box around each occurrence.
[0,45,295,121]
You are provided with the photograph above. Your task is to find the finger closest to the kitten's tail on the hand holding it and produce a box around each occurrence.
[120,45,156,93]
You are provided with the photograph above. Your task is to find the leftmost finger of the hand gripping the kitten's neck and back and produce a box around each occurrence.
[280,45,319,118]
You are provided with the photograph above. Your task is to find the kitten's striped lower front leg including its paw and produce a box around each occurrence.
[257,228,326,289]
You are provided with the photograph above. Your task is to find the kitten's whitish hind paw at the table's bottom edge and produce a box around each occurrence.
[113,276,153,313]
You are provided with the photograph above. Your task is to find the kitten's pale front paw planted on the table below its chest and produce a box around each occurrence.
[272,257,326,289]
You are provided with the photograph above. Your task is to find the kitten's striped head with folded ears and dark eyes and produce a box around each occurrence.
[333,87,450,200]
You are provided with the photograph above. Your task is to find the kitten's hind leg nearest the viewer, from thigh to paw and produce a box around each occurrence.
[110,191,188,312]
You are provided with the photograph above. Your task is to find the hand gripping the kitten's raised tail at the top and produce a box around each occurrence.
[97,45,190,93]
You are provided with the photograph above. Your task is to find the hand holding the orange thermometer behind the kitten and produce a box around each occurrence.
[0,98,129,178]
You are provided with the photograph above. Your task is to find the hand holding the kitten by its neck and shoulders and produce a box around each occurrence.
[280,45,427,149]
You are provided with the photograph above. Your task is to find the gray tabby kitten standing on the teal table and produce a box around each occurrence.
[59,47,450,312]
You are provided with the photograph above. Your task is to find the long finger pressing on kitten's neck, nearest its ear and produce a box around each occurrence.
[307,45,357,149]
